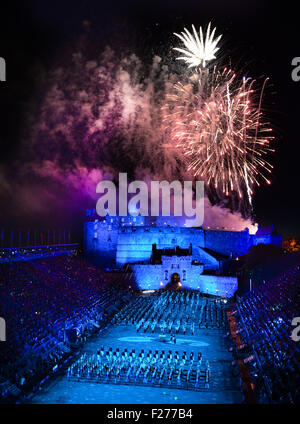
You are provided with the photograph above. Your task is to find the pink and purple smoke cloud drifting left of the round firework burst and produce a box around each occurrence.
[0,30,262,232]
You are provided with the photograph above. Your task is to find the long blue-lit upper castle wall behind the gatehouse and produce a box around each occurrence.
[84,218,281,266]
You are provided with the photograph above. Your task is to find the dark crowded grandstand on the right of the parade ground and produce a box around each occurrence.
[236,266,300,403]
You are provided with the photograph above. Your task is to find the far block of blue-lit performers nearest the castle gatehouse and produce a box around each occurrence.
[114,290,226,335]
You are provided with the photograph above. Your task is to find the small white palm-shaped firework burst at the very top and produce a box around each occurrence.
[173,23,222,68]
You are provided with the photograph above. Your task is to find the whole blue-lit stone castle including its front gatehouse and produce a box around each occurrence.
[84,210,282,297]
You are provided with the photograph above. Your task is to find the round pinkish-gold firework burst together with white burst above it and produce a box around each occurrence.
[163,25,273,205]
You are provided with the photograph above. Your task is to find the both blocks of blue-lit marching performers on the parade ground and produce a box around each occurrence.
[68,290,225,390]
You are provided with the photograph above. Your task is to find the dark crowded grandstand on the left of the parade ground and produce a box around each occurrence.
[0,256,134,399]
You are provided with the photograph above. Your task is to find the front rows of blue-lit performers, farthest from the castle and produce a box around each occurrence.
[67,347,210,390]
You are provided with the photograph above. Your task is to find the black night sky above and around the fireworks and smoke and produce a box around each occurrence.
[0,0,300,235]
